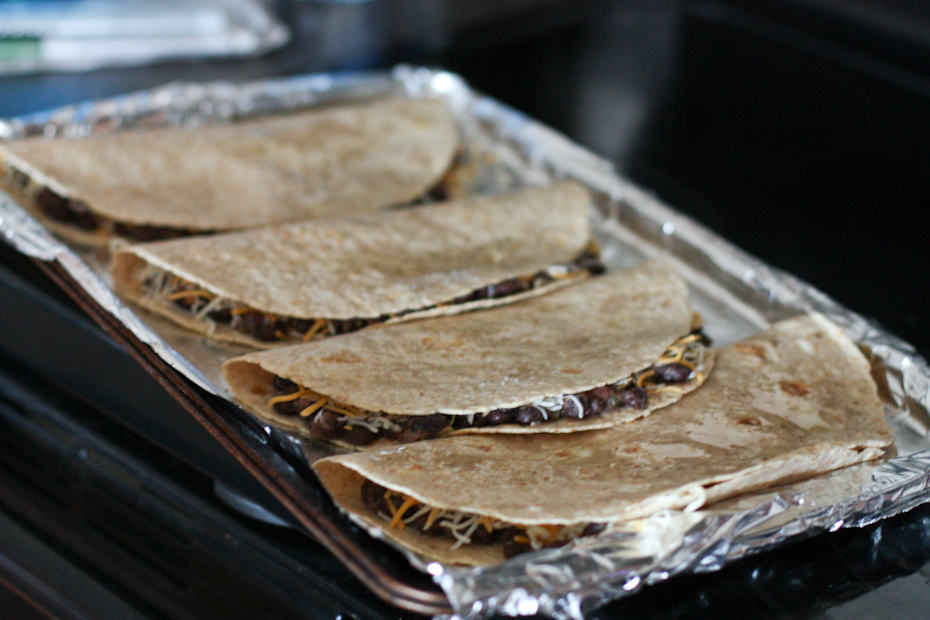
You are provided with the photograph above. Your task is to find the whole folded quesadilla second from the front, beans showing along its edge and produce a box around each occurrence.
[223,262,713,446]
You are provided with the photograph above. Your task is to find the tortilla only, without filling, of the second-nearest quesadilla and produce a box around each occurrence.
[223,261,711,444]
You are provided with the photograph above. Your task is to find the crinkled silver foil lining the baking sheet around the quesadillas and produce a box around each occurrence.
[0,67,930,618]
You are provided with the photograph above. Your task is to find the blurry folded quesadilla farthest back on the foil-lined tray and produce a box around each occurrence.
[0,99,458,244]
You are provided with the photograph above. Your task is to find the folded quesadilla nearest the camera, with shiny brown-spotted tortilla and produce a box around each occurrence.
[314,315,892,565]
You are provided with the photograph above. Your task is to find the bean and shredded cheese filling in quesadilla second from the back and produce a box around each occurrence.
[142,246,604,342]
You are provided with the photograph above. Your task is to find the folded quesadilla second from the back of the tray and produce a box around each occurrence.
[113,182,603,347]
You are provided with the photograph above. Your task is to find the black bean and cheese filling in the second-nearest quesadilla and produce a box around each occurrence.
[268,328,710,446]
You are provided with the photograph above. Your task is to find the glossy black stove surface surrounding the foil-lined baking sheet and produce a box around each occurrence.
[0,0,930,617]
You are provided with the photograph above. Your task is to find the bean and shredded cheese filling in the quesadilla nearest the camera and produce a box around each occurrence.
[361,480,606,558]
